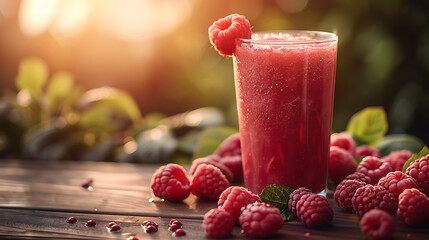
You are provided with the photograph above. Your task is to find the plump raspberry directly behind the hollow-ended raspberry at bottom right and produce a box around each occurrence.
[352,184,397,217]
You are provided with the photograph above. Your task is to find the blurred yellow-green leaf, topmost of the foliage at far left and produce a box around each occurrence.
[15,58,48,97]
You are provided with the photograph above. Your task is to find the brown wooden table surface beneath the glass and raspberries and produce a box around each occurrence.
[0,160,429,240]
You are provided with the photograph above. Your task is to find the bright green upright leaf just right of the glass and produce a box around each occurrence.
[347,107,388,146]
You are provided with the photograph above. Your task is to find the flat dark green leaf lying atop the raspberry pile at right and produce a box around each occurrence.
[376,134,424,156]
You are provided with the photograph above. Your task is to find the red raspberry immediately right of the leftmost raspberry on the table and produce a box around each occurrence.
[191,164,229,200]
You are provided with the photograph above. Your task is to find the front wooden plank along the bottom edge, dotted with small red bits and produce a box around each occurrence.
[0,209,429,240]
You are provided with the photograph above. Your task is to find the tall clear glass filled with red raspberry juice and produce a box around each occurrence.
[233,31,338,194]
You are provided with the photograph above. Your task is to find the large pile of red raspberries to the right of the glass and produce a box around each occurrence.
[329,133,429,239]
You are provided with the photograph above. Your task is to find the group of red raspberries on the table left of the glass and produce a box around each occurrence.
[150,133,243,202]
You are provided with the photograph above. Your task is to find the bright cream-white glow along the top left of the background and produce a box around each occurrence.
[19,0,192,42]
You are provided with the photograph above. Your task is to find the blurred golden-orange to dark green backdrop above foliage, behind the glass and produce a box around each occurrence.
[0,0,429,148]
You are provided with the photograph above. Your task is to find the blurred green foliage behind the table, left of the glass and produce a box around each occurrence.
[0,58,232,163]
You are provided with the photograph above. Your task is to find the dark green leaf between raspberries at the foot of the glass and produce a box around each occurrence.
[259,184,295,221]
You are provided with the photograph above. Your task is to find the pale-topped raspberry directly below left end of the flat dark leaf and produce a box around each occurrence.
[356,156,392,184]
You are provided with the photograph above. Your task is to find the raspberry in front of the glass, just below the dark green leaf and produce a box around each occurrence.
[239,202,283,237]
